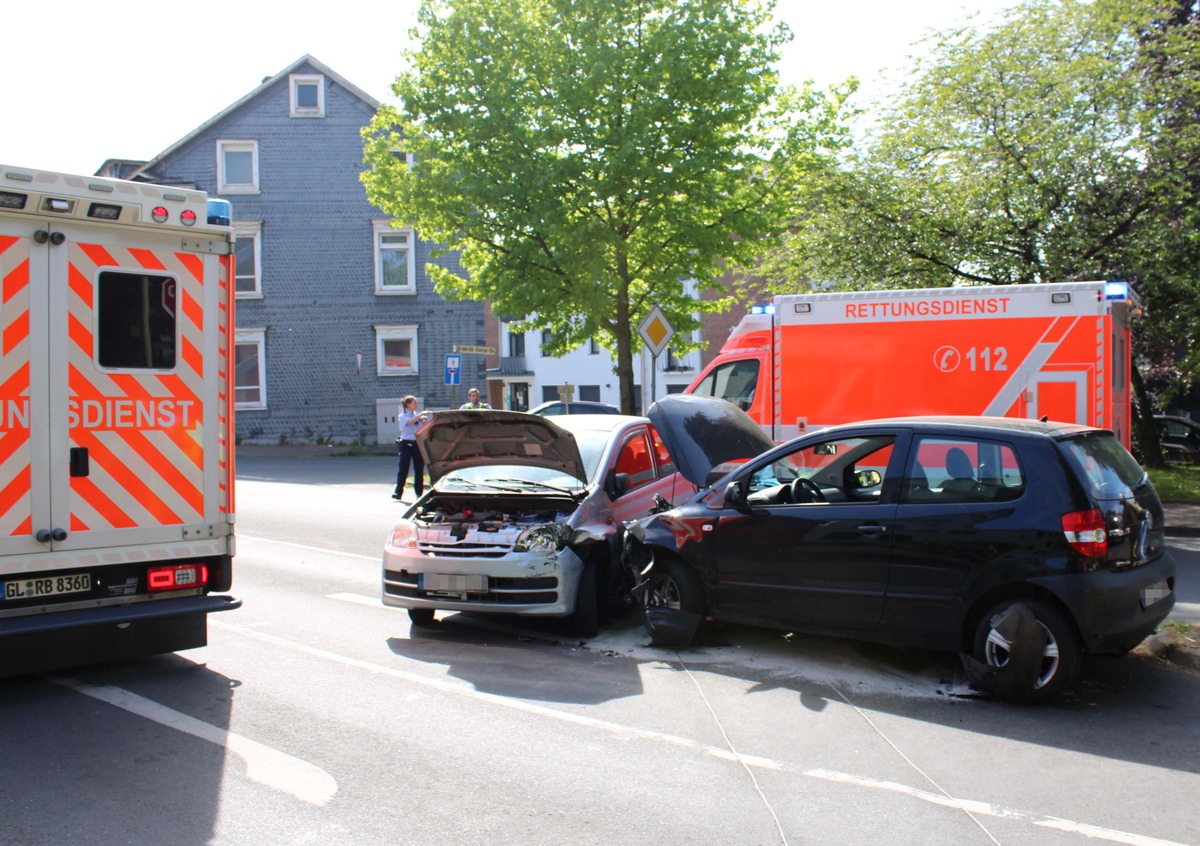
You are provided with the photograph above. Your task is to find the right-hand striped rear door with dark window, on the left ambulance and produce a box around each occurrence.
[48,218,222,557]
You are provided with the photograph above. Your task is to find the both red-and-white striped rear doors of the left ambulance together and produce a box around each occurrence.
[0,210,227,554]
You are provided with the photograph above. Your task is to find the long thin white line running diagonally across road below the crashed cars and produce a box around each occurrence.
[209,614,1187,846]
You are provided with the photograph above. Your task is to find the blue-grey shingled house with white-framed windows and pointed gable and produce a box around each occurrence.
[101,55,486,444]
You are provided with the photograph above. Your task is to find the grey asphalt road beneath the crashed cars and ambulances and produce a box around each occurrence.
[0,457,1200,846]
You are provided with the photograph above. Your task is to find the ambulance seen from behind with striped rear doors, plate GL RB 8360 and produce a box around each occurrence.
[0,166,240,676]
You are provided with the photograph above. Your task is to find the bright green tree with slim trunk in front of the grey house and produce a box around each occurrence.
[362,0,848,412]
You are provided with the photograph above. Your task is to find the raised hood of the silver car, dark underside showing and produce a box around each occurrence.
[416,410,588,481]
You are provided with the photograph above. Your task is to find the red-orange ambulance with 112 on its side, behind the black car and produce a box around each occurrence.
[685,282,1140,449]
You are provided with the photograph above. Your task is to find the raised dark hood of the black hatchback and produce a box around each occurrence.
[647,394,775,487]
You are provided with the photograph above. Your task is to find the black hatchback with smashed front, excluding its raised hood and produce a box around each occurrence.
[624,418,1175,701]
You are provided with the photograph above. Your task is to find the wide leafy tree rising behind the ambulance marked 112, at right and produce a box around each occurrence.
[766,0,1200,462]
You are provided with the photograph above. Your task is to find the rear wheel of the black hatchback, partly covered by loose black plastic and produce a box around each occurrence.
[974,599,1084,703]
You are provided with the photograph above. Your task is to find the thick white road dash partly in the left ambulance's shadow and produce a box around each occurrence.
[54,676,337,806]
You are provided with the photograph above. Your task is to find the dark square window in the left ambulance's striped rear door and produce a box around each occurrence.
[96,270,176,370]
